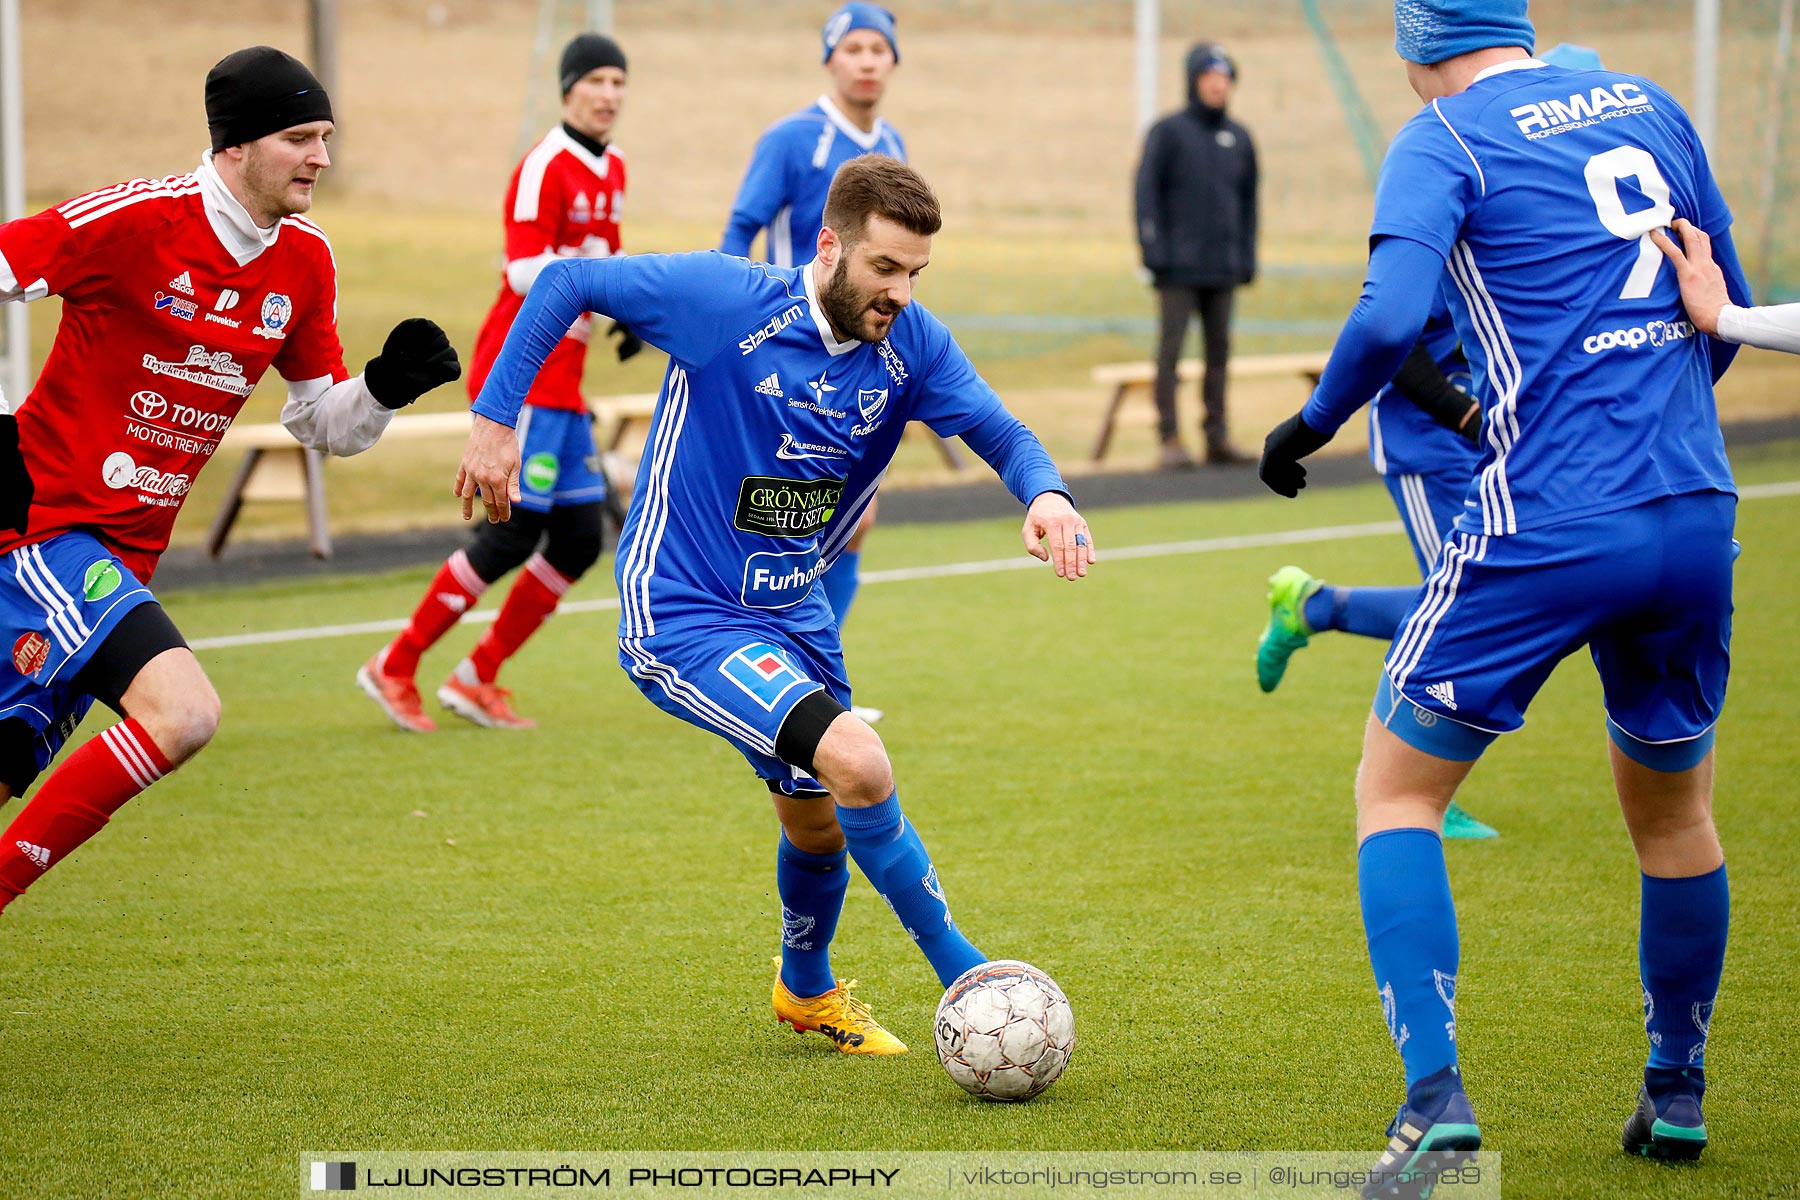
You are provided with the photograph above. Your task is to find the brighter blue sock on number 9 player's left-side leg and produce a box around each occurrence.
[1357,829,1460,1103]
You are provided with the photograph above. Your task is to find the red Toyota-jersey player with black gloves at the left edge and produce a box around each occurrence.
[0,47,461,909]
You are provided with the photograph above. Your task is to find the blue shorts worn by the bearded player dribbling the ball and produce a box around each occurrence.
[619,613,850,795]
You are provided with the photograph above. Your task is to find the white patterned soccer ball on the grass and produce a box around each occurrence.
[932,959,1075,1099]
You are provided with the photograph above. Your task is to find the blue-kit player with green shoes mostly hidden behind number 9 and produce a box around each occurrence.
[1256,297,1499,840]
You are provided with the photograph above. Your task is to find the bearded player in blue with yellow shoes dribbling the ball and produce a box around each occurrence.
[457,155,1094,1054]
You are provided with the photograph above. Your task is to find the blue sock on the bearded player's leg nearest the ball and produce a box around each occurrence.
[837,792,988,988]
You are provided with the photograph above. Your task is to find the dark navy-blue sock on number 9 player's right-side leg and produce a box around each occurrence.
[1638,865,1732,1079]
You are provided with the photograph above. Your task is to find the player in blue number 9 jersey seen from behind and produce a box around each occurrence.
[1262,0,1748,1195]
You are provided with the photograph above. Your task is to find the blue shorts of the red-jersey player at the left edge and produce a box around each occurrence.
[0,533,157,772]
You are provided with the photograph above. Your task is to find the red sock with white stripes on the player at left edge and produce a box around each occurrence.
[0,718,171,909]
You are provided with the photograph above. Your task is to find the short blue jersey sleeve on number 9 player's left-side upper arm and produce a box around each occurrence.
[1368,104,1487,261]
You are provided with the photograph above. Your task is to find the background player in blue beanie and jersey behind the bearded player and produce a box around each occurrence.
[718,0,905,721]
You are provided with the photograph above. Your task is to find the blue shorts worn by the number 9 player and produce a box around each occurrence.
[1375,491,1737,759]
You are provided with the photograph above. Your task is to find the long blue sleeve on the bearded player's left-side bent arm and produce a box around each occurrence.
[475,250,760,425]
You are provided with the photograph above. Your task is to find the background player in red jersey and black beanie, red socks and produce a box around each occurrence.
[356,34,643,734]
